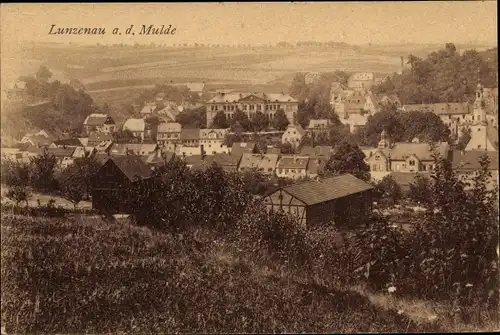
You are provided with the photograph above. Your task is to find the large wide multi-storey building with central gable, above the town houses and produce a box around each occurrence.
[205,93,298,127]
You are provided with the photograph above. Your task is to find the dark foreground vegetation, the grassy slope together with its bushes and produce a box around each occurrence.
[2,154,498,333]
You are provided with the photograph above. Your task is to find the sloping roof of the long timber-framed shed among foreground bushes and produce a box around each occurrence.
[283,173,373,205]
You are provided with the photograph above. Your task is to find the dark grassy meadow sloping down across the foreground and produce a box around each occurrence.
[1,214,448,333]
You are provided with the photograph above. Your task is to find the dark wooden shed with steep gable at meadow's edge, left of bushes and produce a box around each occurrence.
[92,155,152,214]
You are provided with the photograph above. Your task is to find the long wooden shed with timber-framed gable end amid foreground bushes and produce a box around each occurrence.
[263,174,373,227]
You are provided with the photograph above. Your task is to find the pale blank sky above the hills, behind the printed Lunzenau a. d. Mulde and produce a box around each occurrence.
[1,1,497,47]
